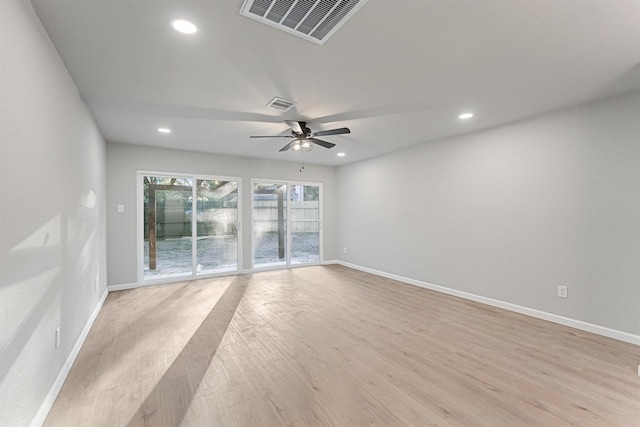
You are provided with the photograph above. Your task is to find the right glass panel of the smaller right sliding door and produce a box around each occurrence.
[289,185,320,265]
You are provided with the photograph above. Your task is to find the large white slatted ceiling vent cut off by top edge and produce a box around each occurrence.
[240,0,368,44]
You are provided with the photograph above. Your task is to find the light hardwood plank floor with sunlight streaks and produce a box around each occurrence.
[45,266,640,427]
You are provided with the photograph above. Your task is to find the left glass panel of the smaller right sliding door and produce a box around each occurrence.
[253,183,287,267]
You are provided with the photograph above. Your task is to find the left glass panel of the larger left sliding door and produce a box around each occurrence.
[143,176,193,280]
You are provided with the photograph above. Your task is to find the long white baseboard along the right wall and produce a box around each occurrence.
[336,260,640,345]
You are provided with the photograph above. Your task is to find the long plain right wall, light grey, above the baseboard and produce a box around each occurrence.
[338,92,640,335]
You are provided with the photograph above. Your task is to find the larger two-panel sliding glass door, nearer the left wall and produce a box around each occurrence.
[138,172,240,281]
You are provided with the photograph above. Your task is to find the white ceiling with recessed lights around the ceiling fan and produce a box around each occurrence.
[32,0,640,165]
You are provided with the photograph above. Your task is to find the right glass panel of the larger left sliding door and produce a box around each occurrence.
[196,179,238,275]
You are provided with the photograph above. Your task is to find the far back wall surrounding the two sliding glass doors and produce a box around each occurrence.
[107,143,337,285]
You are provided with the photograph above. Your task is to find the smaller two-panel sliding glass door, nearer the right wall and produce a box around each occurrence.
[252,181,322,268]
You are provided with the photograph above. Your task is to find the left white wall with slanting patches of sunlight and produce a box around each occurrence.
[0,0,106,426]
